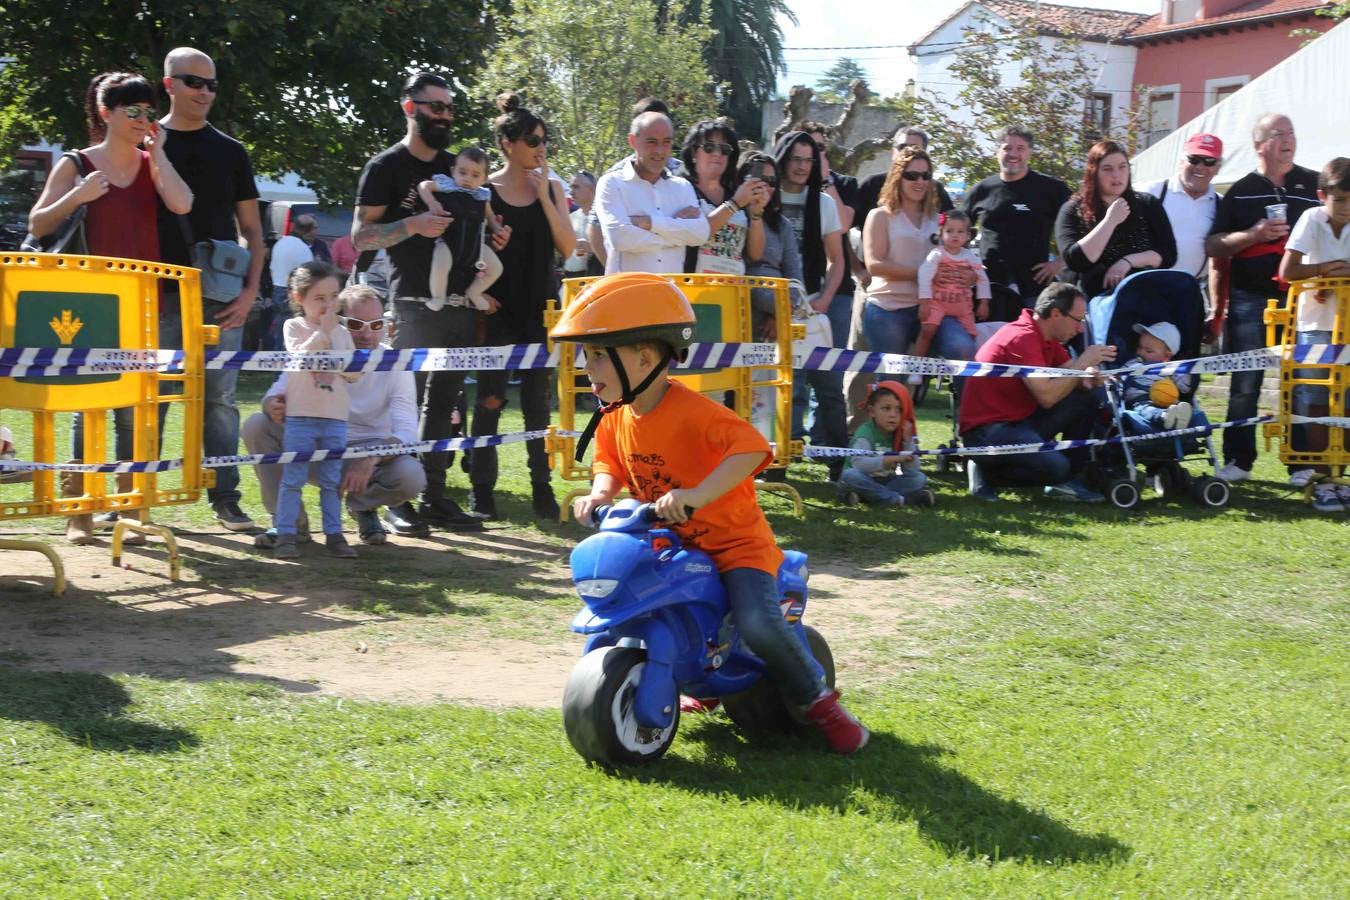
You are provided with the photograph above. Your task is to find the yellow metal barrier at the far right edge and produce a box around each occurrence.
[1264,278,1350,502]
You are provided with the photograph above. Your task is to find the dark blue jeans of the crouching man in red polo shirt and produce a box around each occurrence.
[961,387,1106,490]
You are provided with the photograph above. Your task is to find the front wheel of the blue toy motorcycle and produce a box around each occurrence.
[563,646,679,766]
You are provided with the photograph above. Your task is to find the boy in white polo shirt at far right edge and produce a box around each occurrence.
[1280,157,1350,513]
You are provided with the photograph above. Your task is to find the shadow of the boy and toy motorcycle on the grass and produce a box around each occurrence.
[620,719,1133,865]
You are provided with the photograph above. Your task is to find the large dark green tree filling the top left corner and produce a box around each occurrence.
[0,0,505,202]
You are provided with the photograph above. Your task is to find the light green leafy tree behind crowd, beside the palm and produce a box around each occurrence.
[477,0,720,171]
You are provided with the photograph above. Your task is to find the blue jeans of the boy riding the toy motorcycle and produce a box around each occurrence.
[722,568,825,707]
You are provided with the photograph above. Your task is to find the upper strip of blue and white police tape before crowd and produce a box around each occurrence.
[0,341,1350,378]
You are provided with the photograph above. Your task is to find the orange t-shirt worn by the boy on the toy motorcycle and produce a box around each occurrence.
[591,381,783,576]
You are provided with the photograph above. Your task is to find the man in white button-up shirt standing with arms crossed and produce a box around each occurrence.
[595,112,709,275]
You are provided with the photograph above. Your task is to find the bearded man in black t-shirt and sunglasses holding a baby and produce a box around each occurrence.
[351,73,482,534]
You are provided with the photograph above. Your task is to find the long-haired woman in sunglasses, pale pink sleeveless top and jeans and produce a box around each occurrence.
[863,146,975,369]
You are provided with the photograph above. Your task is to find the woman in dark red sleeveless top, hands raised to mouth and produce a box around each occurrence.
[28,72,192,544]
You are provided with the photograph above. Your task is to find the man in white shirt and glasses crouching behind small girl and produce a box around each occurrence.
[243,285,428,548]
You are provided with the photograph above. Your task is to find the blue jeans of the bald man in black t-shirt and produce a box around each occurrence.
[159,294,244,506]
